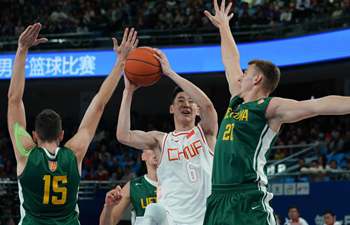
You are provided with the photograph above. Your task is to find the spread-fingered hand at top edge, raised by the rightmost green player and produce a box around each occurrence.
[204,0,234,28]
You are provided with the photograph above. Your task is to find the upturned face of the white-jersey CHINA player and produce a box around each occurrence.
[170,92,198,123]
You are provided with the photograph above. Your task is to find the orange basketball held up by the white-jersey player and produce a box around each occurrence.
[124,47,161,87]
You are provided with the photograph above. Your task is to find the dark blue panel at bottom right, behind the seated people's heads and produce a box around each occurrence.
[271,181,350,225]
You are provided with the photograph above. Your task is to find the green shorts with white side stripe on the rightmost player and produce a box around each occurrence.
[204,184,276,225]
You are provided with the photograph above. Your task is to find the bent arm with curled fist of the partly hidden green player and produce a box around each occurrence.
[100,181,131,225]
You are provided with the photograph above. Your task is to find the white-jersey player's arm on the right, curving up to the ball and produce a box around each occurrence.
[155,49,218,149]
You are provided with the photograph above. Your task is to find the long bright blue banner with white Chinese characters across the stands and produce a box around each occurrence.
[0,29,350,79]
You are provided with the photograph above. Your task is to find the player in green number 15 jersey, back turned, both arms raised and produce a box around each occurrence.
[8,23,137,225]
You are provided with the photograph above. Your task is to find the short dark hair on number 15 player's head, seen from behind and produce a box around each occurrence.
[35,109,62,142]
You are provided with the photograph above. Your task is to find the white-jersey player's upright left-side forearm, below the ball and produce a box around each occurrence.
[117,89,133,140]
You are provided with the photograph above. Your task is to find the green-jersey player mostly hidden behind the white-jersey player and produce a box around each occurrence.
[100,150,158,225]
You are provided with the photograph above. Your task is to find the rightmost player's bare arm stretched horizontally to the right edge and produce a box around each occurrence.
[266,95,350,131]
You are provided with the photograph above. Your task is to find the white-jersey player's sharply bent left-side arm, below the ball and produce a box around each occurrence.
[116,76,164,151]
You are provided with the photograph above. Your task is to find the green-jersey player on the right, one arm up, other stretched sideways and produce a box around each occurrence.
[204,0,350,225]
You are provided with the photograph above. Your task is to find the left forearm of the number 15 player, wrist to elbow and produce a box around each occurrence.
[8,48,28,101]
